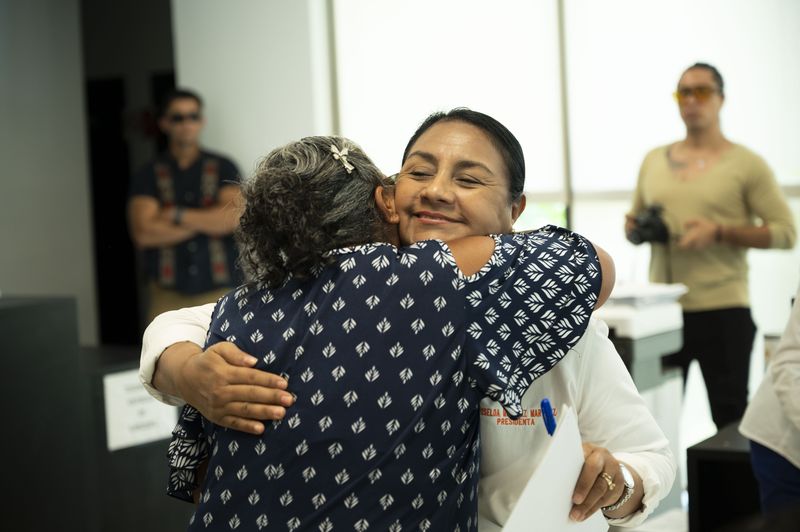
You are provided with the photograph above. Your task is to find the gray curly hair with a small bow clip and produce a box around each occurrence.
[236,136,391,287]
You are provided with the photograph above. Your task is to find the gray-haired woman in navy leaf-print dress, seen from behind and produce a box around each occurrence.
[158,132,612,531]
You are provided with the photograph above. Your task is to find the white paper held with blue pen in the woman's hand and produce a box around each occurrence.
[503,405,608,532]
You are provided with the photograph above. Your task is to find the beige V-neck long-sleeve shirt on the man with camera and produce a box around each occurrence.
[631,144,796,311]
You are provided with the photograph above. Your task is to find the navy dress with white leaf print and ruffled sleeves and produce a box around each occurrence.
[169,227,601,532]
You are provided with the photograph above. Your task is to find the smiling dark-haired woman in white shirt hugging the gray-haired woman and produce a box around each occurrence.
[141,109,675,530]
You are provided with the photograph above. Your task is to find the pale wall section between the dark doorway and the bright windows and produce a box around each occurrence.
[172,0,332,179]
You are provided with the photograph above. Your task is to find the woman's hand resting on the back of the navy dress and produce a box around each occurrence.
[177,342,294,434]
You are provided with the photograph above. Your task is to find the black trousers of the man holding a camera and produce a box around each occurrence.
[662,308,756,430]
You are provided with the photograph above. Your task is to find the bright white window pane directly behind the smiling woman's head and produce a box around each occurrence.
[334,0,564,193]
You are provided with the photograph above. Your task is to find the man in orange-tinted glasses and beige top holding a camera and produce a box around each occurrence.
[625,63,796,429]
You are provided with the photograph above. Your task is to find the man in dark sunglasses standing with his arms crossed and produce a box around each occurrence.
[128,90,242,322]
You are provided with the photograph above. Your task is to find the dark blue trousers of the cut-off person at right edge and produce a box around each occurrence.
[750,441,800,512]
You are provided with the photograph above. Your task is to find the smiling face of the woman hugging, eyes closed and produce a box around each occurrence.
[395,120,525,244]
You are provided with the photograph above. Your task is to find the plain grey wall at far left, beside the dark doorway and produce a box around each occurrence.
[0,0,97,344]
